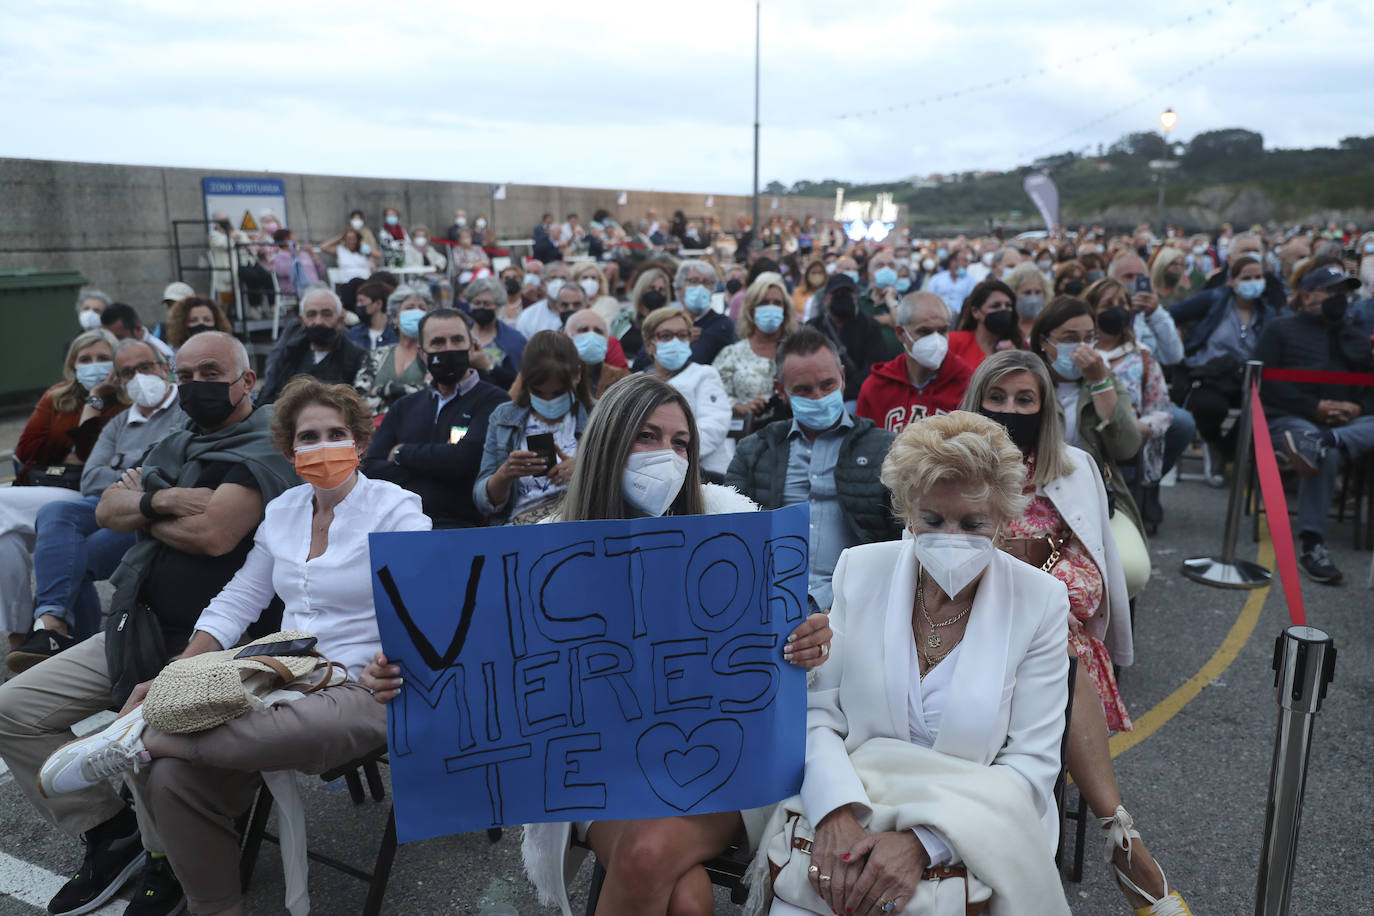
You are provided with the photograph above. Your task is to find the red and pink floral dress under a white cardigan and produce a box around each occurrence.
[1007,459,1131,732]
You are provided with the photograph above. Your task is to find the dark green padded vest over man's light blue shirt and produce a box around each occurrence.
[725,416,901,544]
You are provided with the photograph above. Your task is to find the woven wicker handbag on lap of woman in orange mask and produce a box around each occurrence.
[143,630,348,735]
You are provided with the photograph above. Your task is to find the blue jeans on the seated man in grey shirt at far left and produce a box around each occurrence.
[33,496,135,640]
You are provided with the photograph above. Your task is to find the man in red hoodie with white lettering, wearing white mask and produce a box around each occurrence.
[855,293,973,433]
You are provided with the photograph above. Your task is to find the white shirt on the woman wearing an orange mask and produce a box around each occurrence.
[195,474,430,681]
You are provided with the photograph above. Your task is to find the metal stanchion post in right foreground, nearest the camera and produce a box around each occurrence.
[1254,626,1336,916]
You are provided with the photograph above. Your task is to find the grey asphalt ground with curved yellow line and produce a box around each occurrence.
[0,453,1374,916]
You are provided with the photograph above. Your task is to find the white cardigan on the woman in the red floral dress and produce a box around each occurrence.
[1040,445,1135,667]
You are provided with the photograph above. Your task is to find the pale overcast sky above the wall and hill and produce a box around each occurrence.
[0,0,1374,194]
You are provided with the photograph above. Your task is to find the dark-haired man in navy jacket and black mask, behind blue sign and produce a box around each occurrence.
[363,309,508,527]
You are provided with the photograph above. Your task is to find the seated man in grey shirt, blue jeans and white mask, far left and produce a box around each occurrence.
[8,341,187,673]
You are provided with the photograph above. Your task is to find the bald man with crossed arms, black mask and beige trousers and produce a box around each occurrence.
[0,331,298,913]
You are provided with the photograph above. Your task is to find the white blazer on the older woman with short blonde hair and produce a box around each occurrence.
[801,540,1069,857]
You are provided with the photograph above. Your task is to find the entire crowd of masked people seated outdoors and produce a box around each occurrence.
[0,207,1374,916]
